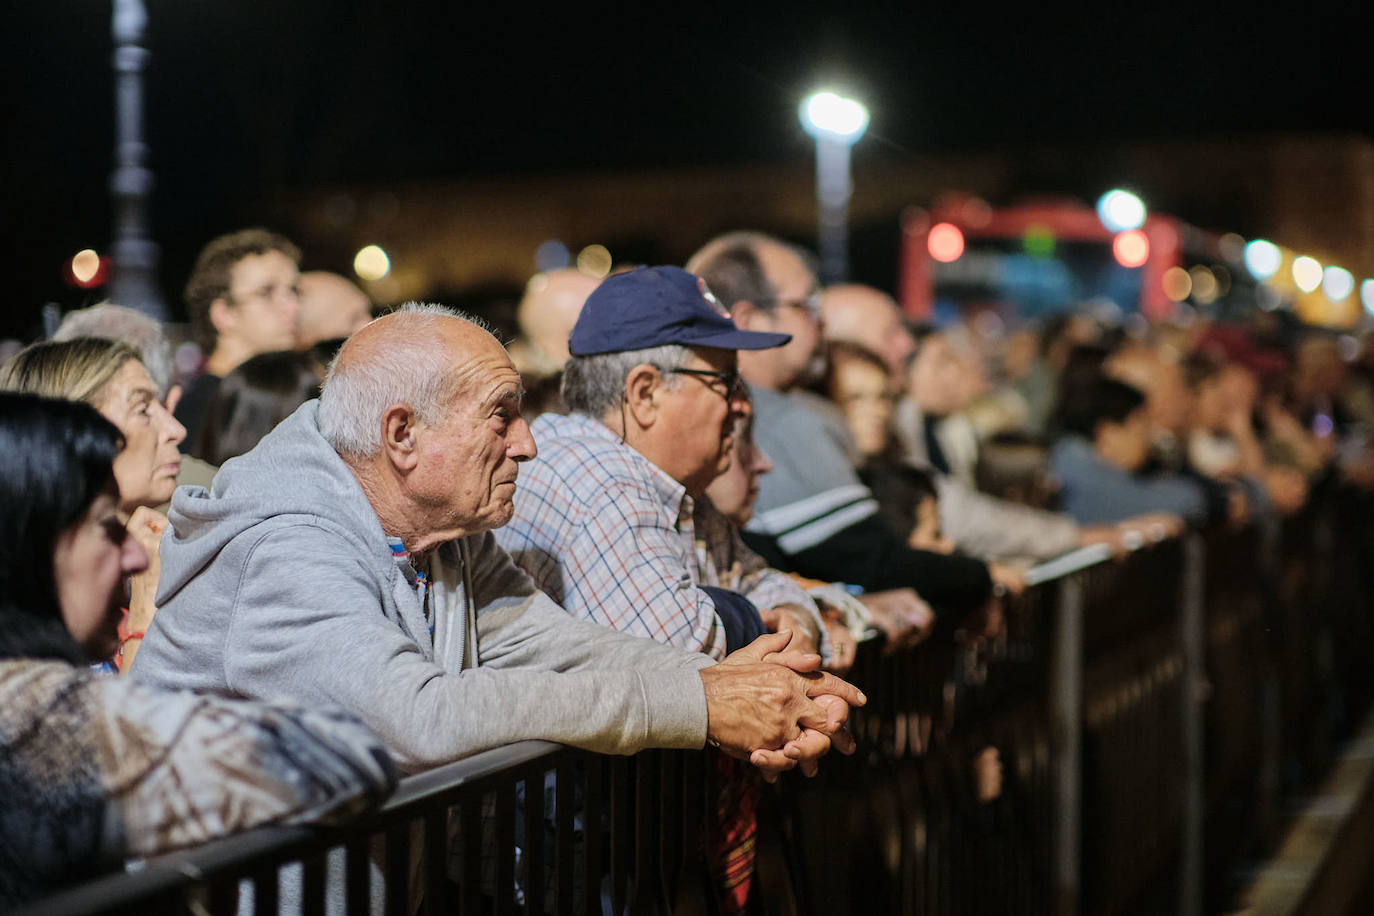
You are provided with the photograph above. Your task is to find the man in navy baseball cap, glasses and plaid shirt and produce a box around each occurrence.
[497,266,829,659]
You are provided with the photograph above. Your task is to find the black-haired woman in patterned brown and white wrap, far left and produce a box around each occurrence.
[0,393,396,909]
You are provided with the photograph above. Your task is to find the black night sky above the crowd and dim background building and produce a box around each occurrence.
[0,0,1374,338]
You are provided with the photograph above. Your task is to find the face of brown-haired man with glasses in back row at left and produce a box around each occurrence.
[218,251,301,356]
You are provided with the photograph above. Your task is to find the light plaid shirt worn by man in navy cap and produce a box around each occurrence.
[496,413,811,659]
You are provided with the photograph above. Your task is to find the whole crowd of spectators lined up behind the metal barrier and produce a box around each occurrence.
[0,219,1374,912]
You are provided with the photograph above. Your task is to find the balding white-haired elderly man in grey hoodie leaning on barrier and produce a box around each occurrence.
[135,306,864,775]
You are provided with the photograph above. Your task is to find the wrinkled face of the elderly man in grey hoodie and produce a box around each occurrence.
[411,328,537,536]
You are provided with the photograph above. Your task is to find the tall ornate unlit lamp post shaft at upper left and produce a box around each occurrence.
[110,0,168,320]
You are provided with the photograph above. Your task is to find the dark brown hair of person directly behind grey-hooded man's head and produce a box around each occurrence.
[190,350,320,466]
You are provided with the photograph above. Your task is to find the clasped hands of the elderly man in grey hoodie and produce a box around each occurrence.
[699,630,867,781]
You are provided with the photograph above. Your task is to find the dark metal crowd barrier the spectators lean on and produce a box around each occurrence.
[21,483,1374,916]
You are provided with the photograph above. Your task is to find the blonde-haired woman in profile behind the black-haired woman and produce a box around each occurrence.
[0,338,185,670]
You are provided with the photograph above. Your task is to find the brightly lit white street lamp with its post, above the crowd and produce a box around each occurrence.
[800,92,868,284]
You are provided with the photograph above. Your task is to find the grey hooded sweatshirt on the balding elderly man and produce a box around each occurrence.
[133,401,712,772]
